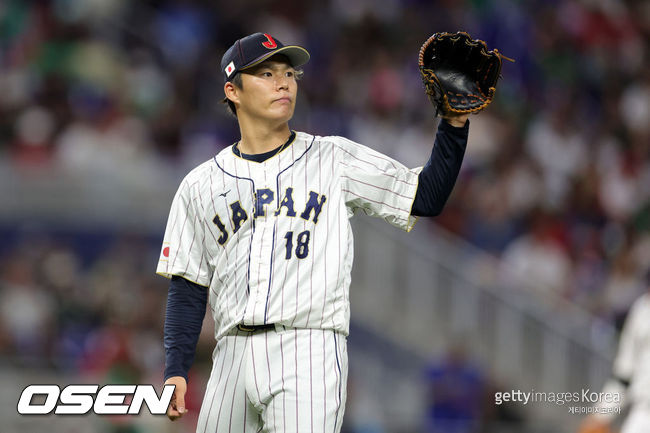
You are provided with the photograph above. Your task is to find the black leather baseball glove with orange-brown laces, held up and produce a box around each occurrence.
[418,32,514,117]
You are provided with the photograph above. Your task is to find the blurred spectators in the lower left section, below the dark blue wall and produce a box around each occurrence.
[0,232,165,383]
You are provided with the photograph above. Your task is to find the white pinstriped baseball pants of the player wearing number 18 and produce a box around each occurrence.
[196,325,348,433]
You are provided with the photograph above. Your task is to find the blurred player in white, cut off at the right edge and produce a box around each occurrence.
[580,269,650,433]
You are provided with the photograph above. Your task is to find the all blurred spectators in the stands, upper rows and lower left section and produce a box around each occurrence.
[0,0,650,428]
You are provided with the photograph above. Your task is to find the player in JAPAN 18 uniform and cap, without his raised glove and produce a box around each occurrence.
[157,33,469,433]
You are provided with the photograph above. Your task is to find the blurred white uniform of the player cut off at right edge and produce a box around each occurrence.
[603,293,650,433]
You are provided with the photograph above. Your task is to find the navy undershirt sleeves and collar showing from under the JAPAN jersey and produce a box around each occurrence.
[164,120,469,380]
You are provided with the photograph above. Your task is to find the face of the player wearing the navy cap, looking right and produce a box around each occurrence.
[237,60,298,122]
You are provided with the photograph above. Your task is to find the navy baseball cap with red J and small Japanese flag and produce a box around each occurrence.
[221,33,309,81]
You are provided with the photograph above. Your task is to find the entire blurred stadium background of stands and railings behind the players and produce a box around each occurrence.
[0,0,650,433]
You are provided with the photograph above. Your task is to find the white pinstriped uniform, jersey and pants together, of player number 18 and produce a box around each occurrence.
[157,133,419,433]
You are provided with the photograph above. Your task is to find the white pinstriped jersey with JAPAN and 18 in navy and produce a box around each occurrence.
[157,132,421,338]
